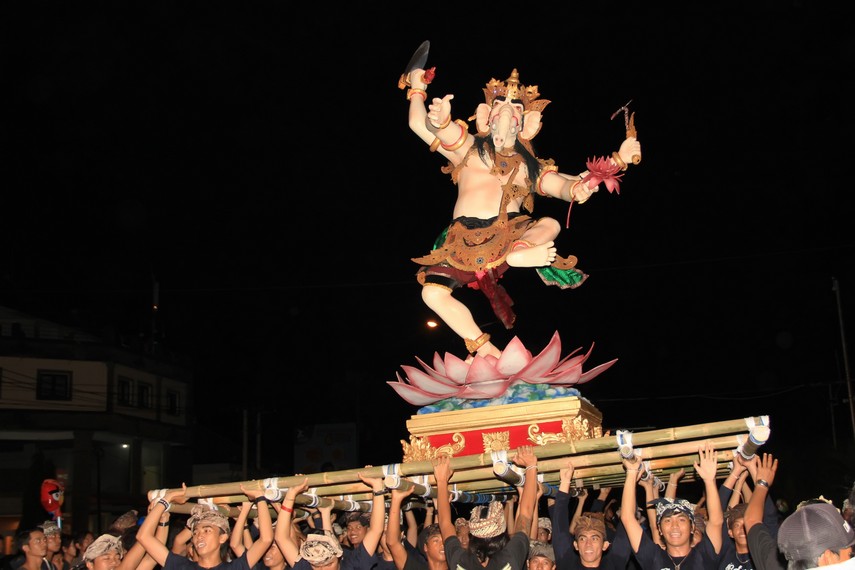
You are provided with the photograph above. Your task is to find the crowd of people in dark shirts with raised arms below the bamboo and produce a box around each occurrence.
[4,444,855,570]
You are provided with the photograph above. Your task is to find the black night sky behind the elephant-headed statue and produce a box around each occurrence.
[6,2,855,502]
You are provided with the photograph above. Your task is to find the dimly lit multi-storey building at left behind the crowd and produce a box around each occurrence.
[0,307,194,536]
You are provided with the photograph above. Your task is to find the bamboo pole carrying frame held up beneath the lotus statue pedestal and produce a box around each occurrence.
[148,416,769,518]
